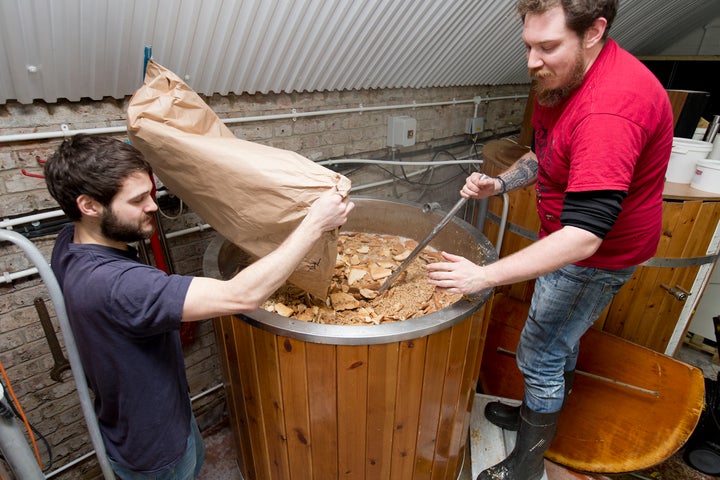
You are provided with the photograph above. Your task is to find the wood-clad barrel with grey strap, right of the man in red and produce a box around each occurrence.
[596,183,720,355]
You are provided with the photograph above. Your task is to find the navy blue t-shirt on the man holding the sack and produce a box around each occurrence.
[51,225,192,473]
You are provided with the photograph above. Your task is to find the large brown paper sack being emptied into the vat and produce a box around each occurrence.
[127,61,350,298]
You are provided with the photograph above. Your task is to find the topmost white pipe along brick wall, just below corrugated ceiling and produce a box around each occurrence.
[0,94,528,143]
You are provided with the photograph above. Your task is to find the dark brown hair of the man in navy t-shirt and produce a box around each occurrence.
[44,134,152,221]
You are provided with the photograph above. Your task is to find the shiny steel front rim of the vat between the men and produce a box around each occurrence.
[235,289,492,345]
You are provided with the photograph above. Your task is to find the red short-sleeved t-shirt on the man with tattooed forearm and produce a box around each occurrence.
[532,39,673,270]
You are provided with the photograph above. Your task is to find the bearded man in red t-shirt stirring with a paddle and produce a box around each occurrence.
[428,0,673,480]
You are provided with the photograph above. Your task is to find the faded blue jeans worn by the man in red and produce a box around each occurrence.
[517,265,635,413]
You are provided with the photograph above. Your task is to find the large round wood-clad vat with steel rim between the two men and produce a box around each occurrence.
[205,199,497,480]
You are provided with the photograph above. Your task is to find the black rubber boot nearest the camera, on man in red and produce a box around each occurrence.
[477,405,560,480]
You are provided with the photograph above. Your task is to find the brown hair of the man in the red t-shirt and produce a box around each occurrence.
[517,0,620,39]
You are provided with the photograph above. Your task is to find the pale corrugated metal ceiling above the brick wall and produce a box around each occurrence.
[0,0,720,103]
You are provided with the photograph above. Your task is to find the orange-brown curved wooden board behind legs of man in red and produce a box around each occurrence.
[480,295,705,473]
